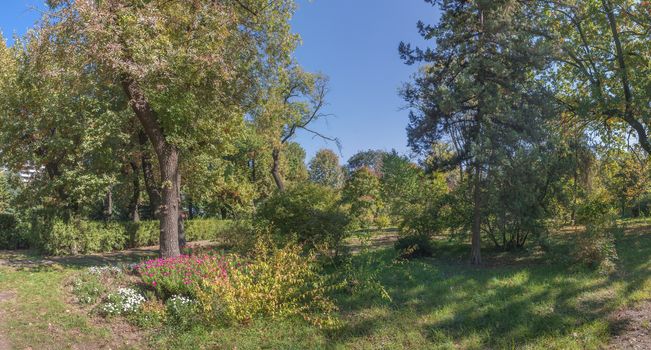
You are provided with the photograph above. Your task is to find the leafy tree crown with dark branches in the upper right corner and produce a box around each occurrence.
[539,0,651,153]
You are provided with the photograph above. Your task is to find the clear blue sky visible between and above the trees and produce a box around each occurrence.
[0,0,438,161]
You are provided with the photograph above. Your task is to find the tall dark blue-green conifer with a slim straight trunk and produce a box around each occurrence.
[399,0,548,264]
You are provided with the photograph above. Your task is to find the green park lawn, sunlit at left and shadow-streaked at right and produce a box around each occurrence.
[0,222,651,349]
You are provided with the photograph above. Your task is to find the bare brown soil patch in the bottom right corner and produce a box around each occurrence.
[607,301,651,349]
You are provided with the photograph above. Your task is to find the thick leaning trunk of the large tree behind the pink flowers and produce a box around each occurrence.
[122,76,181,258]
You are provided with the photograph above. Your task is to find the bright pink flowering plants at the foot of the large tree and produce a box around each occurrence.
[136,254,236,299]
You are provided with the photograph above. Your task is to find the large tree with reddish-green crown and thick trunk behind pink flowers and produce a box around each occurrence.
[34,0,297,257]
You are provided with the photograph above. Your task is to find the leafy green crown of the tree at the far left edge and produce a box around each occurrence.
[0,31,128,218]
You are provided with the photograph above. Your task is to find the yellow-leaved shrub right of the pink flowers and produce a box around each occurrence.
[199,241,336,326]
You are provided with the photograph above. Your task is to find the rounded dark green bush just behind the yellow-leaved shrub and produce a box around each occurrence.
[257,183,349,252]
